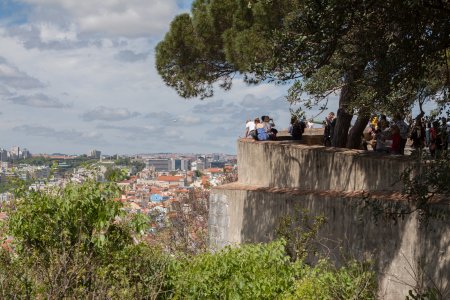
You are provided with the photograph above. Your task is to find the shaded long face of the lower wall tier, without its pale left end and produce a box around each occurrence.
[241,191,450,299]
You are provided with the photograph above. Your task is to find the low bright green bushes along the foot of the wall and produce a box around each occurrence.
[168,240,377,300]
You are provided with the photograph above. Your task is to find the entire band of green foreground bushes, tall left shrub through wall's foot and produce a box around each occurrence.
[0,182,376,299]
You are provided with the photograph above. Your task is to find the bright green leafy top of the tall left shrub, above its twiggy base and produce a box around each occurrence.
[9,182,127,252]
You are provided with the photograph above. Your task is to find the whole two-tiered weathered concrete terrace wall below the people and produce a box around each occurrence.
[209,140,450,299]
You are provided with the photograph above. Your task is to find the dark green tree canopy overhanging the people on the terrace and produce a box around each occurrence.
[156,0,450,146]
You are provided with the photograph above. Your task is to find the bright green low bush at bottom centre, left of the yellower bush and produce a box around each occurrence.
[169,241,299,299]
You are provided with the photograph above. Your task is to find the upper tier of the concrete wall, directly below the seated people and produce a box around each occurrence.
[238,139,411,191]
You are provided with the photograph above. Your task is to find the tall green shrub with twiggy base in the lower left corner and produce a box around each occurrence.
[0,182,168,299]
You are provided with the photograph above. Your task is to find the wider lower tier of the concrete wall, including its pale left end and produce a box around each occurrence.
[209,183,450,299]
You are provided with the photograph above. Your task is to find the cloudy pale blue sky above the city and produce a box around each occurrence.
[0,0,338,154]
